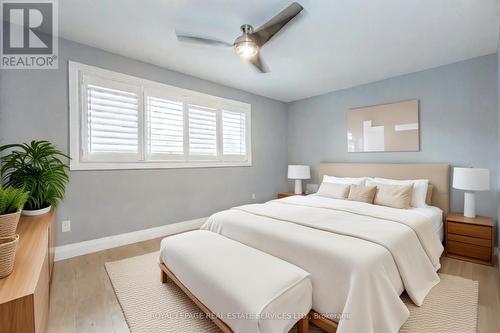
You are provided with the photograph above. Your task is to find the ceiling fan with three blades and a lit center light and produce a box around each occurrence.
[176,2,304,73]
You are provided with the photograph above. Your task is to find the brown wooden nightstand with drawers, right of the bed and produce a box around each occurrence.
[446,213,493,266]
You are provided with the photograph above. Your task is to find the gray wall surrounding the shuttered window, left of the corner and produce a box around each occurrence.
[0,40,287,245]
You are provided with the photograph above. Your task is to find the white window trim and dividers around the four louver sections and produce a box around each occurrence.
[68,61,252,170]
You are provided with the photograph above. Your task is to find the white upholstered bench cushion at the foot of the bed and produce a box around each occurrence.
[160,230,312,333]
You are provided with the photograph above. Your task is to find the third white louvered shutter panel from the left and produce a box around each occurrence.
[188,104,217,156]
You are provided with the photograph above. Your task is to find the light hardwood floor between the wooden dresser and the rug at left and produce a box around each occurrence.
[48,239,160,333]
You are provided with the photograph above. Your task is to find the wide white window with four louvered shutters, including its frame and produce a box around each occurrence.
[69,62,251,170]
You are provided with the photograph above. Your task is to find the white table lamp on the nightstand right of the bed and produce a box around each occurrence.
[453,168,490,217]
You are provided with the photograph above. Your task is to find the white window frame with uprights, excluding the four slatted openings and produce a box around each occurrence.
[68,61,252,170]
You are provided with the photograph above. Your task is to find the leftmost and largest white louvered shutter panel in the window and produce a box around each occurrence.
[87,84,139,153]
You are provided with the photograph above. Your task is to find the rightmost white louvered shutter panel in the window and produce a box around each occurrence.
[222,110,246,156]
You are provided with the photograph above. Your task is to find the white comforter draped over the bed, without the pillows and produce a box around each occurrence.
[202,196,443,333]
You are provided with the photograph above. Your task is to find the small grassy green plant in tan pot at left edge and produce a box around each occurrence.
[0,187,29,237]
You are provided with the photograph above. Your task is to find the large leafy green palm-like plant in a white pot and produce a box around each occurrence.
[0,141,69,215]
